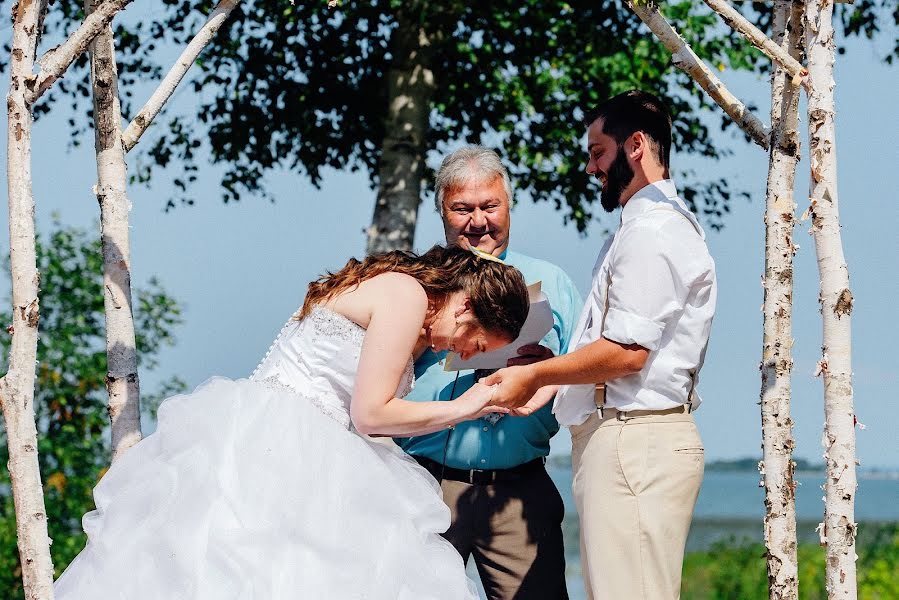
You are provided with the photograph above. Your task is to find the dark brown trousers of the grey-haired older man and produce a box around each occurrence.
[441,469,568,600]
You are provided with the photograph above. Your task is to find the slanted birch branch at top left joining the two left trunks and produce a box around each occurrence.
[26,0,132,104]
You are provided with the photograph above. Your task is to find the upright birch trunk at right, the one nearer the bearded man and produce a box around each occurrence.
[761,0,803,600]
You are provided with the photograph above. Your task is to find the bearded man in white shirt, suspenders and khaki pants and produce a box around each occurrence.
[487,90,716,600]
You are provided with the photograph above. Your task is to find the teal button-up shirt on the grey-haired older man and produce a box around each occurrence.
[396,251,583,469]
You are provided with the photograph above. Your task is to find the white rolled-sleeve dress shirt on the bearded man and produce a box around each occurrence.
[553,179,717,426]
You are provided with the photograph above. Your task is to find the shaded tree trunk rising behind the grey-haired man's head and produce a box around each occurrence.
[368,2,435,253]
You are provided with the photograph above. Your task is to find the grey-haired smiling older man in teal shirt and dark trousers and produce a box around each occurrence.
[397,146,581,600]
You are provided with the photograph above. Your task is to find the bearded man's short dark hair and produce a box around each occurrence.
[583,90,671,168]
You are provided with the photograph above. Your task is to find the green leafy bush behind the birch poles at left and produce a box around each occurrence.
[0,223,184,598]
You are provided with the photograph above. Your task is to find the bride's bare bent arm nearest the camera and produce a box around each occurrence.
[350,274,493,436]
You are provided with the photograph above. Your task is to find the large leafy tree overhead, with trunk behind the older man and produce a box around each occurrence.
[5,0,899,245]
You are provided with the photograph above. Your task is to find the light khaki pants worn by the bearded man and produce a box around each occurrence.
[571,411,704,600]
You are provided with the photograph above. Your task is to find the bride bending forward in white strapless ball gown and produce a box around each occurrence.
[55,246,528,600]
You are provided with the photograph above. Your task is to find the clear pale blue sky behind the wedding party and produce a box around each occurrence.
[0,10,899,467]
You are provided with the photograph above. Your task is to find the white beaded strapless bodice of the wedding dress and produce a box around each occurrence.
[250,306,414,427]
